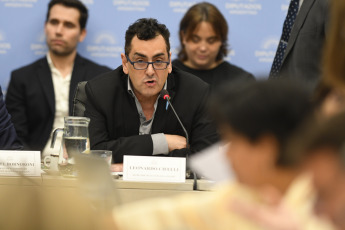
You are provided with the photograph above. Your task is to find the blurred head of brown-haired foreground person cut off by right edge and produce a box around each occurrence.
[299,112,345,229]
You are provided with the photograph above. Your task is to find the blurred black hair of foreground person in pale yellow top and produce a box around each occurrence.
[210,80,313,167]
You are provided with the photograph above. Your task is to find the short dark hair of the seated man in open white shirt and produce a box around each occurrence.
[46,0,89,30]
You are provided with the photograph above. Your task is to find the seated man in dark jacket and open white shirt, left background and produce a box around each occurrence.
[6,0,110,155]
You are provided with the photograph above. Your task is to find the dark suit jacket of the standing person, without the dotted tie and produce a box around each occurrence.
[268,0,329,87]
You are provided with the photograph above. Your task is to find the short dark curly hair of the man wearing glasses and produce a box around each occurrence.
[125,18,170,55]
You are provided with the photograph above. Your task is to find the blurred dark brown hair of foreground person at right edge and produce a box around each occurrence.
[294,112,345,166]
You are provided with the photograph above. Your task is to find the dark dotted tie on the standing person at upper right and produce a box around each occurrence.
[270,0,299,78]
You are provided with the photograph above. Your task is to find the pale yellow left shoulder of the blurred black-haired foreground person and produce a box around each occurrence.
[113,182,261,230]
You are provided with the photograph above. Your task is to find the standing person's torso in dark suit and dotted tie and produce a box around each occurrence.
[270,0,329,88]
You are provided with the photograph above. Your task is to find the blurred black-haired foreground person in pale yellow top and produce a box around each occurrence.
[113,81,332,230]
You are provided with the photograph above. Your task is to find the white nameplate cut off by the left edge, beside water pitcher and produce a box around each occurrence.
[0,150,41,176]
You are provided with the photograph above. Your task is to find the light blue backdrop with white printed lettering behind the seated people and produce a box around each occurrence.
[0,0,289,91]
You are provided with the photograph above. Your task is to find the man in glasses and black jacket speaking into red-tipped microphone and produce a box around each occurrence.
[85,18,218,163]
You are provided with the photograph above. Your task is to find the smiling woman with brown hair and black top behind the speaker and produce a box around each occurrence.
[172,2,254,90]
